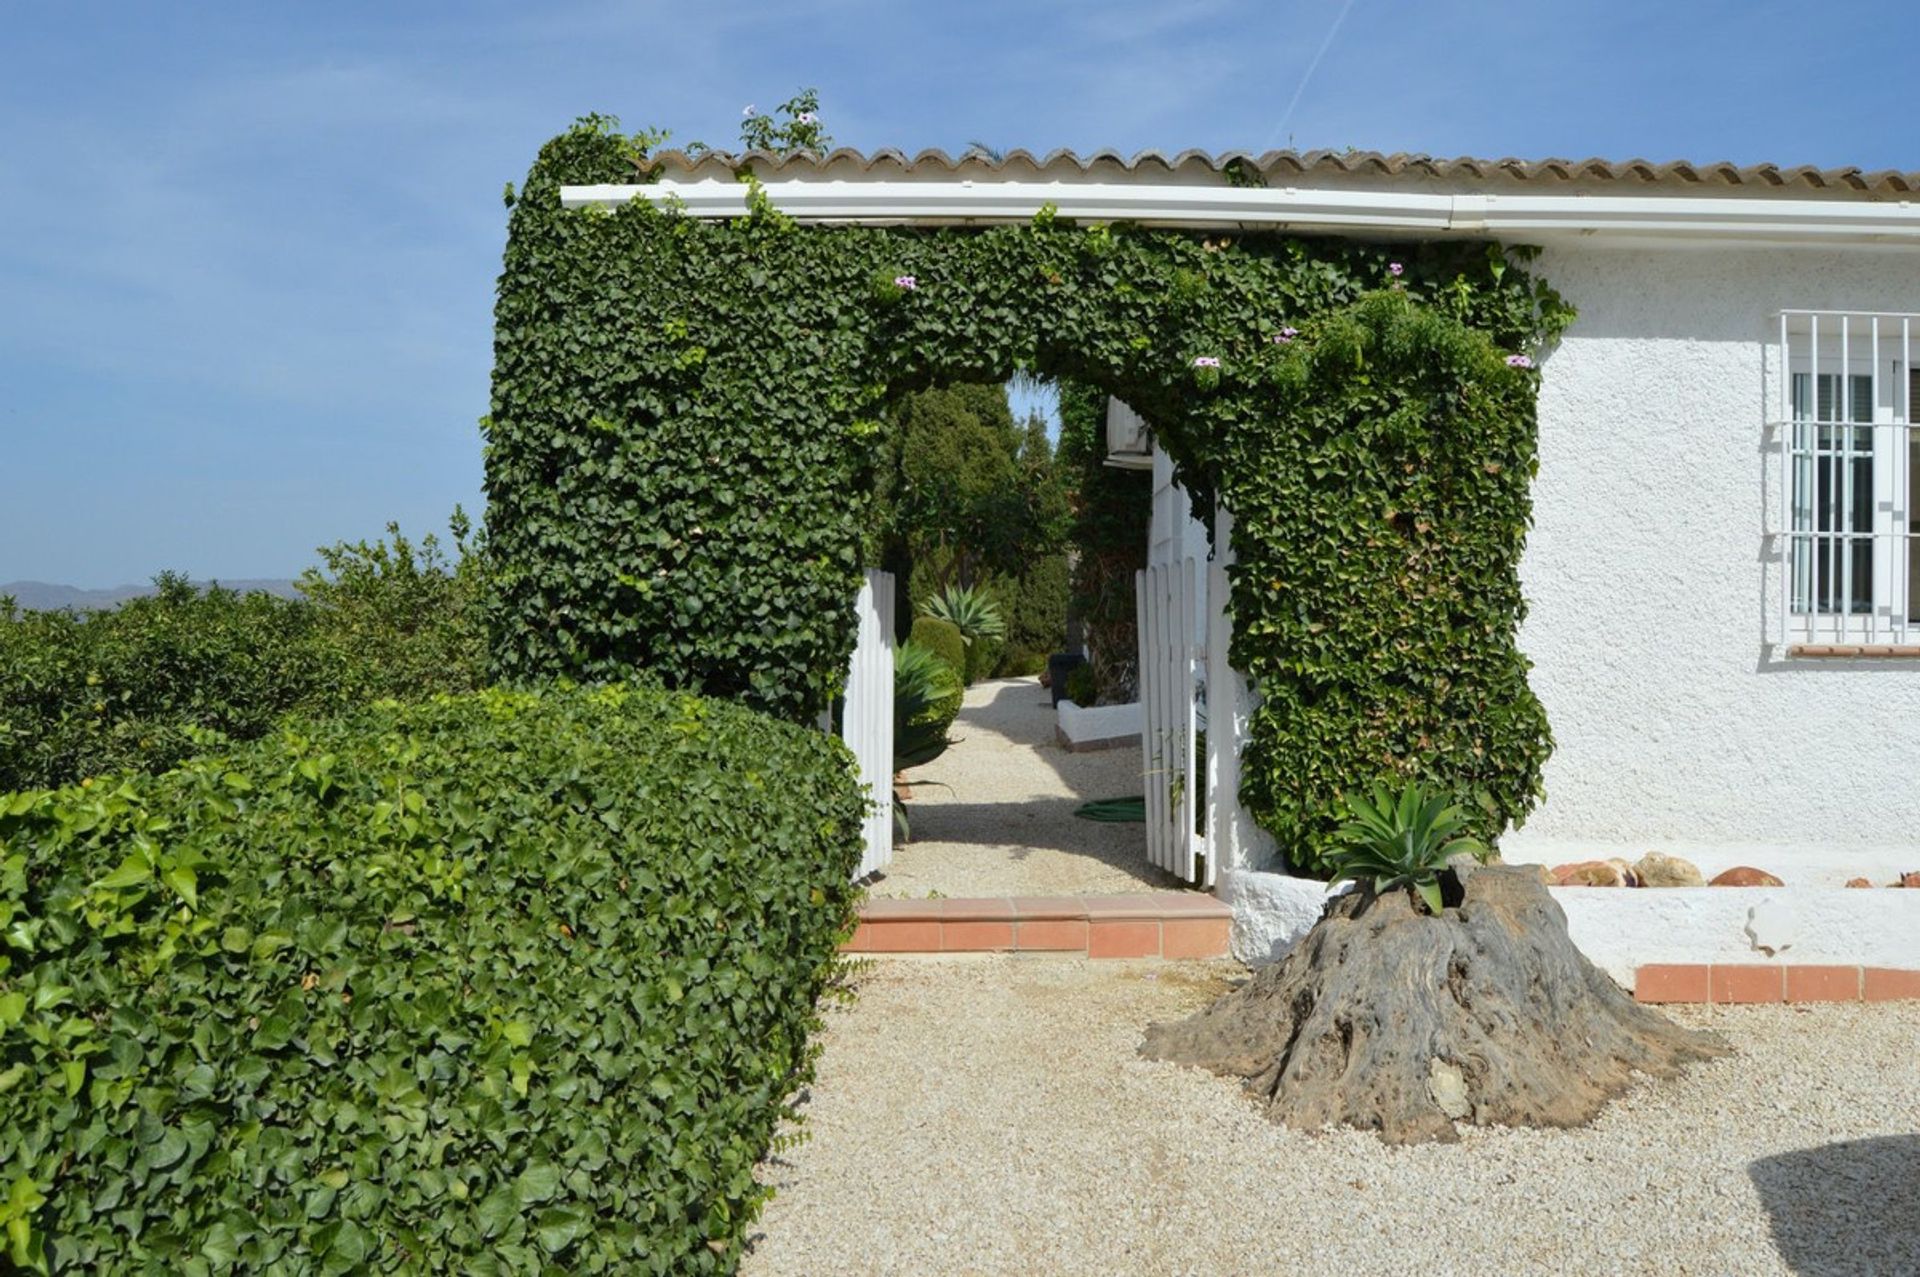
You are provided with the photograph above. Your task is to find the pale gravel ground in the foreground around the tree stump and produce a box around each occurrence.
[741,956,1920,1277]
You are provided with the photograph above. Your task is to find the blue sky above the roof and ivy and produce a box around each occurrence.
[0,0,1920,586]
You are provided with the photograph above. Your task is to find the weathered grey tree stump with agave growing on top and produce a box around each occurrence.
[1140,866,1730,1144]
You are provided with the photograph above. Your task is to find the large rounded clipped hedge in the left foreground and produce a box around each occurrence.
[0,687,862,1273]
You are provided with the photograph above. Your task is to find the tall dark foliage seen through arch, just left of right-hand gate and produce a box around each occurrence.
[1060,382,1154,705]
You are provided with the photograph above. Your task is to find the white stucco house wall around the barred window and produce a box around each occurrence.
[1505,248,1920,883]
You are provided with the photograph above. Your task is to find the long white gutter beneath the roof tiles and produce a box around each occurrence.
[561,179,1920,242]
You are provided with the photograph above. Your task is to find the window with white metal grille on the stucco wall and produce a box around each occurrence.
[1768,311,1920,655]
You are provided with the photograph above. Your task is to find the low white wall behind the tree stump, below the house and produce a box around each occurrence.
[1219,870,1920,989]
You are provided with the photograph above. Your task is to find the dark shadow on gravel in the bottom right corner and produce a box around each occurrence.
[1747,1135,1920,1277]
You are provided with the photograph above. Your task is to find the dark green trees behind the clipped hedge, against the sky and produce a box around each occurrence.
[0,515,486,793]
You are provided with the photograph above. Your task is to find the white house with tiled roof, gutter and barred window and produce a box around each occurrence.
[563,150,1920,967]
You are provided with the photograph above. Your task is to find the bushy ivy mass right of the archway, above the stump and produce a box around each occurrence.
[1221,292,1551,872]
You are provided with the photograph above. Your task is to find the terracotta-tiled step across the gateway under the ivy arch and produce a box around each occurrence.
[843,891,1233,960]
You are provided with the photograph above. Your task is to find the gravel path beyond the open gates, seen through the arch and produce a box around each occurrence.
[872,678,1181,897]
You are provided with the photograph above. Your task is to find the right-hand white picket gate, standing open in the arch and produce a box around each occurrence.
[1133,559,1213,887]
